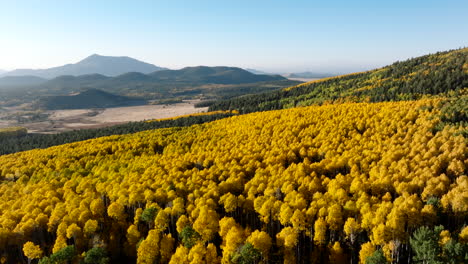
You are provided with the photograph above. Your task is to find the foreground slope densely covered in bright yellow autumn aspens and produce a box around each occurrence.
[0,99,468,264]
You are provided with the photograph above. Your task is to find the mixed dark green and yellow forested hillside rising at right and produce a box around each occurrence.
[210,48,468,112]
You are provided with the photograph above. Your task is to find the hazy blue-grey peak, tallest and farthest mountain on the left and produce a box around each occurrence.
[3,54,164,79]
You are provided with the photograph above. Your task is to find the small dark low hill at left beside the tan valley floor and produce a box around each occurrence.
[37,89,146,110]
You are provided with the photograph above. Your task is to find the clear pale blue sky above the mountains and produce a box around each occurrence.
[0,0,468,72]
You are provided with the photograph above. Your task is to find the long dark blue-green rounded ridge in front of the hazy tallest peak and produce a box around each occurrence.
[35,66,287,95]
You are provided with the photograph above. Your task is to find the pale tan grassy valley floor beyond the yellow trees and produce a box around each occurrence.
[0,101,208,133]
